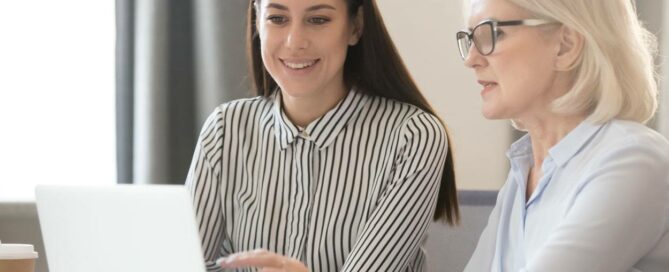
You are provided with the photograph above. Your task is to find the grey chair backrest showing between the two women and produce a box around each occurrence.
[426,191,497,272]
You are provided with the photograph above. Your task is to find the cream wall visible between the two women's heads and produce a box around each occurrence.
[377,0,511,190]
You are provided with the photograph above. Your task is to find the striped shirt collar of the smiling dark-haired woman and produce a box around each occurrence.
[272,89,369,149]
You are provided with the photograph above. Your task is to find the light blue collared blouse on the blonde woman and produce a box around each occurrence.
[465,120,669,272]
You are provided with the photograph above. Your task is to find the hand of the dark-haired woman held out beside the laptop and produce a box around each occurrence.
[216,249,309,272]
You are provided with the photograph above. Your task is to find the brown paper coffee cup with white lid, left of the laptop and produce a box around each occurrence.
[0,242,37,272]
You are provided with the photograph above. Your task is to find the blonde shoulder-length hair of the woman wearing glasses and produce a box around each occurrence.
[509,0,658,123]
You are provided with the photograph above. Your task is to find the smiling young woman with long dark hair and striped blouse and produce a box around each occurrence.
[187,0,458,271]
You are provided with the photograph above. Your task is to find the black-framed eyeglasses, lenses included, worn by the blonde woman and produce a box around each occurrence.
[456,19,554,60]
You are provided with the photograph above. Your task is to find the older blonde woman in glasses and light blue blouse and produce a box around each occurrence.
[457,0,669,272]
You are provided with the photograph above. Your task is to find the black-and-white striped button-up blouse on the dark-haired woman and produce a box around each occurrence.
[186,90,448,271]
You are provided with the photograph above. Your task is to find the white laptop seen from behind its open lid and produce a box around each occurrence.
[35,185,205,272]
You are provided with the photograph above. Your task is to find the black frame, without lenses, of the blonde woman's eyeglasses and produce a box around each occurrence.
[455,19,555,60]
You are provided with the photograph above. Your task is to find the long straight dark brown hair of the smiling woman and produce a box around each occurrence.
[247,0,460,225]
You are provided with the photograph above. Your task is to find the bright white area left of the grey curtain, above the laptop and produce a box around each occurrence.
[0,0,116,202]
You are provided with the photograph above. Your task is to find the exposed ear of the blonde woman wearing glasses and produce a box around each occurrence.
[555,26,585,71]
